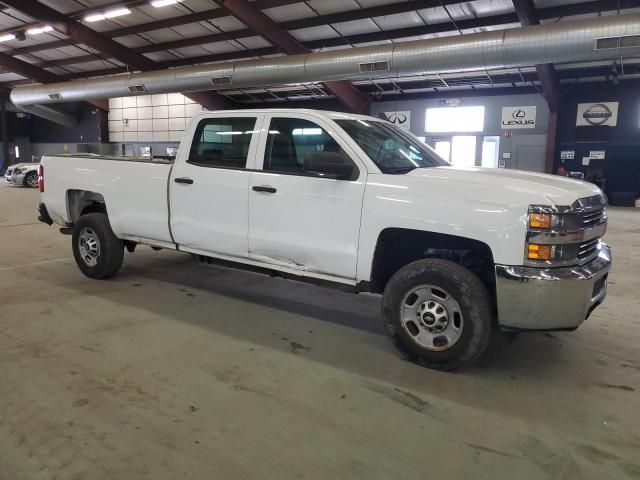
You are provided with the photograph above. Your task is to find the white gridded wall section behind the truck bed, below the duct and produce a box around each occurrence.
[109,93,203,143]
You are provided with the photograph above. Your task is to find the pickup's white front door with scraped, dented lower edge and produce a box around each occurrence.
[249,114,366,280]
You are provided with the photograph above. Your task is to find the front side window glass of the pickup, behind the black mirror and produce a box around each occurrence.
[263,118,346,174]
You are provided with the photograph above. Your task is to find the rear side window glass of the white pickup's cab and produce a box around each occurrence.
[188,117,256,168]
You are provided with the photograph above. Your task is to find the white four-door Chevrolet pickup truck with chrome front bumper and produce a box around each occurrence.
[38,109,611,370]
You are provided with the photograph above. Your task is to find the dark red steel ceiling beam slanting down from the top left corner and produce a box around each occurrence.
[2,0,231,109]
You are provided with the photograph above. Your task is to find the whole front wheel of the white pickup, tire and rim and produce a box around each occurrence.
[382,259,492,370]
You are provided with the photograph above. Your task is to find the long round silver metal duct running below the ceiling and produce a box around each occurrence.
[11,14,640,105]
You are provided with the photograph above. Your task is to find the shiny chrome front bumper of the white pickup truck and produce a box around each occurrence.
[496,244,611,330]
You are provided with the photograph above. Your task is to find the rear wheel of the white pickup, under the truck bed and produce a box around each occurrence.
[72,213,124,279]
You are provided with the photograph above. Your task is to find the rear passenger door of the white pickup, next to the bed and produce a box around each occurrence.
[169,113,263,258]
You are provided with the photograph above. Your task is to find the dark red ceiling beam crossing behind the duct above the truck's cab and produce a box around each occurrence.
[221,0,369,113]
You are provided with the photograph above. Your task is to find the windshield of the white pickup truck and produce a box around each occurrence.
[336,120,449,174]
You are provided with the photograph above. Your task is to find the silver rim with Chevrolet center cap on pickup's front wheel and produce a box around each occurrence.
[400,285,463,352]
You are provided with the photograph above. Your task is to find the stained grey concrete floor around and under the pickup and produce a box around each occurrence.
[0,185,640,480]
